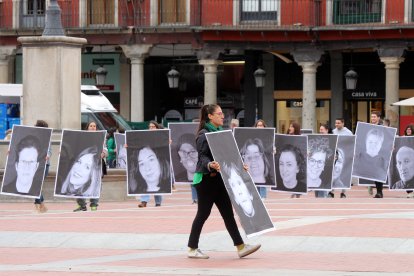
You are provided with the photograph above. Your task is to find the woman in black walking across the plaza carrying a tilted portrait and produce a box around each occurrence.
[187,104,260,259]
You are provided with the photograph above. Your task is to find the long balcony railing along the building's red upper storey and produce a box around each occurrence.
[0,0,414,31]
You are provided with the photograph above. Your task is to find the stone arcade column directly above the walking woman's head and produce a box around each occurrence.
[198,59,222,104]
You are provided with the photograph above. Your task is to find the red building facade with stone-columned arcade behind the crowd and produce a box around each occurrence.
[0,0,414,133]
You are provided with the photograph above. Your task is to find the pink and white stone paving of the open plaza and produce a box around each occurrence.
[0,185,414,276]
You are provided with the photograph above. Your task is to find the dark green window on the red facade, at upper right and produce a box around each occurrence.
[334,0,382,24]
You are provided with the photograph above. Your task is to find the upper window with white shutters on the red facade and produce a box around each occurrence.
[241,0,278,21]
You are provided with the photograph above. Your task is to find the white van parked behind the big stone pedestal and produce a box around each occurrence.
[0,83,131,130]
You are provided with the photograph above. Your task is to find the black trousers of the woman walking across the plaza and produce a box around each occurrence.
[188,174,243,248]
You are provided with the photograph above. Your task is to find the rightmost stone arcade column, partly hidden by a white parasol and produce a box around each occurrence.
[380,57,404,128]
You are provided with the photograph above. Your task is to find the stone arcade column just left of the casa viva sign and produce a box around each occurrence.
[292,49,323,131]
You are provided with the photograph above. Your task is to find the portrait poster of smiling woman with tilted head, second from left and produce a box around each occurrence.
[55,129,106,198]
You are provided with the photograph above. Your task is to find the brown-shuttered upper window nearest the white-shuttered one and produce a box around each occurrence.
[160,0,187,23]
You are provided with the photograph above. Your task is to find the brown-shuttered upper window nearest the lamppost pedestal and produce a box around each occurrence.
[87,0,115,25]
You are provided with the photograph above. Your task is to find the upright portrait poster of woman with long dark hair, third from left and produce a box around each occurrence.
[125,129,172,195]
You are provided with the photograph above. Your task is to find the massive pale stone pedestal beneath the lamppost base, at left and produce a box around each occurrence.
[17,36,86,129]
